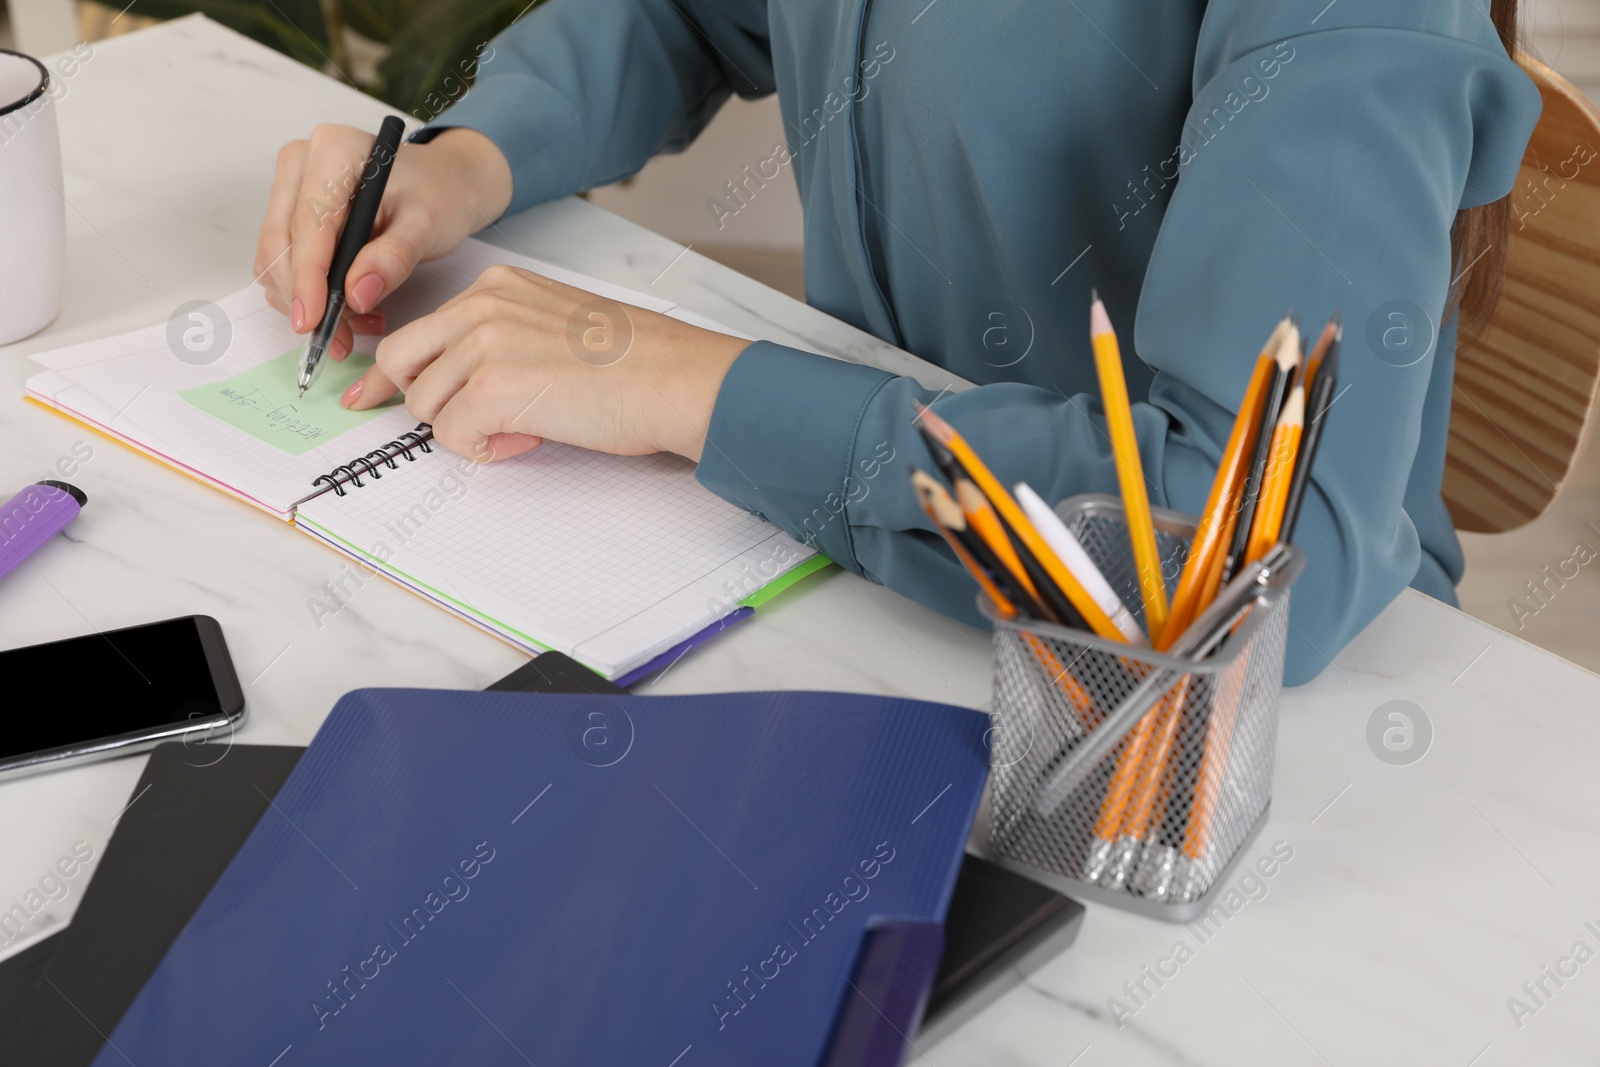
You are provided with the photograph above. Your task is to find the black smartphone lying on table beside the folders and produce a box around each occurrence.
[0,614,245,779]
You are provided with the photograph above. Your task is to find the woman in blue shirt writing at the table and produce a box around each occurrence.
[256,0,1539,683]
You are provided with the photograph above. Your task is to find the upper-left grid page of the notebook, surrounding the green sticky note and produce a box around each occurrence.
[29,240,672,515]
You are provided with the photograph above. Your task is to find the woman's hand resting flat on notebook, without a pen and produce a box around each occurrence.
[342,262,749,462]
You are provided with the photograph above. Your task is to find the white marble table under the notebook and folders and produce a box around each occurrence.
[0,19,1600,1067]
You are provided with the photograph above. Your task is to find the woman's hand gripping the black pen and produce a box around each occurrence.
[253,125,512,360]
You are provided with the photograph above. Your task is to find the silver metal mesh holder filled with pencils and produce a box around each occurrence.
[979,496,1304,921]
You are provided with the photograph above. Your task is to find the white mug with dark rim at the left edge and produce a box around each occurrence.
[0,48,67,344]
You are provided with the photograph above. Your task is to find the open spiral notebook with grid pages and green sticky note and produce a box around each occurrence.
[27,242,826,678]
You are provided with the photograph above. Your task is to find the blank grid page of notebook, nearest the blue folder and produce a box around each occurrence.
[298,443,814,678]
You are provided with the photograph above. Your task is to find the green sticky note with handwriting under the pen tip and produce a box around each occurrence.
[178,349,398,456]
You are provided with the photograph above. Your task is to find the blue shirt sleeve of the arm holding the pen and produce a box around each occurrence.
[421,0,776,213]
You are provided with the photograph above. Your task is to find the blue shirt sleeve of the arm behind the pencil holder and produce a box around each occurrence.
[699,0,1539,683]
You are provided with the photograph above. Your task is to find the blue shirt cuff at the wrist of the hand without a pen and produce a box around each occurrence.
[696,341,893,569]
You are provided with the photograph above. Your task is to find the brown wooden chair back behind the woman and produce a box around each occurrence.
[1443,56,1600,533]
